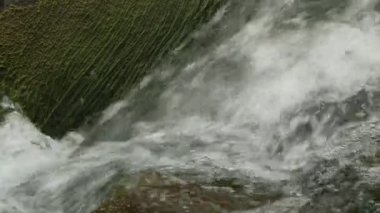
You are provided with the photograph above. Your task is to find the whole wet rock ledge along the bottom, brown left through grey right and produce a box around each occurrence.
[94,104,380,213]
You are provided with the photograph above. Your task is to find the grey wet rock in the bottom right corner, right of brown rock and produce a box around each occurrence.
[300,122,380,213]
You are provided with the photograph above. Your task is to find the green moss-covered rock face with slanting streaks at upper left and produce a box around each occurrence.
[0,0,225,137]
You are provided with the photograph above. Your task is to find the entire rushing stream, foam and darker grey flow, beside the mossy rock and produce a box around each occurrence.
[0,0,380,213]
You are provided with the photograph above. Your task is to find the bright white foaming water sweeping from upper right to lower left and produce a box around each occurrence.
[0,0,380,213]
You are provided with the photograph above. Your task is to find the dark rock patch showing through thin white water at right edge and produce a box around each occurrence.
[272,89,380,154]
